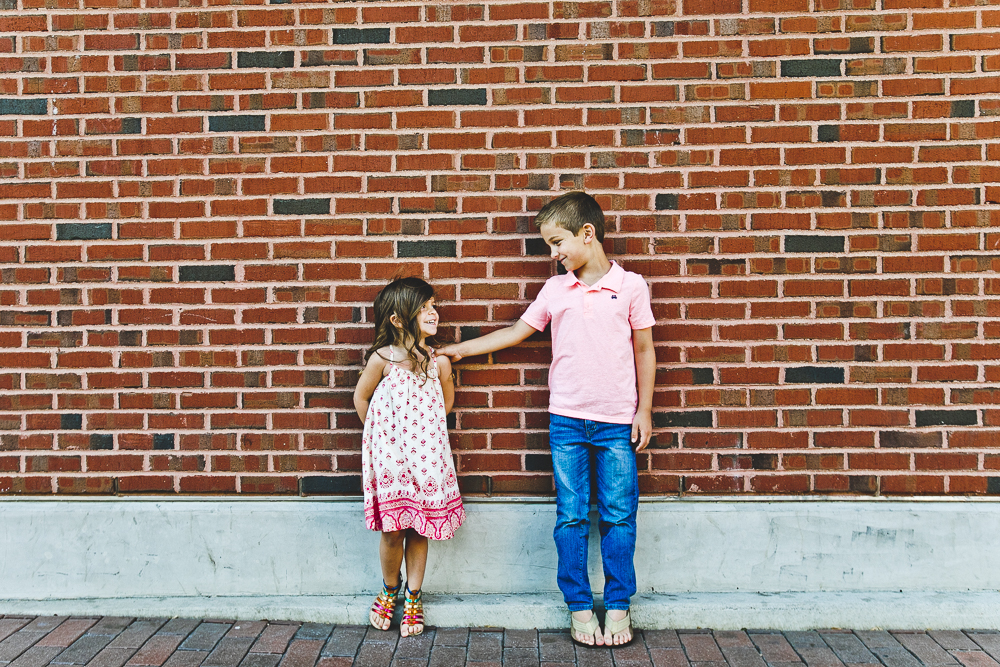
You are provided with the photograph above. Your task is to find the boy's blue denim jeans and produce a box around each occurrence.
[549,414,639,611]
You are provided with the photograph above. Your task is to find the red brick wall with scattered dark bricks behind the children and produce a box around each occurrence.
[0,0,1000,494]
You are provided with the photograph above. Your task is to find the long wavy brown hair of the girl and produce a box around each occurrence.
[365,278,434,377]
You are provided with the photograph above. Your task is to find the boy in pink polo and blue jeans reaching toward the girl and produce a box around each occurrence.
[439,192,656,646]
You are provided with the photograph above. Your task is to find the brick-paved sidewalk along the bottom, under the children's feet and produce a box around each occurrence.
[0,616,1000,667]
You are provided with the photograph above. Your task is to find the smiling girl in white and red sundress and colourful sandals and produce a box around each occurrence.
[354,278,465,637]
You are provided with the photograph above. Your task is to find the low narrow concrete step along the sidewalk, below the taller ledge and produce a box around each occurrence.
[0,591,1000,630]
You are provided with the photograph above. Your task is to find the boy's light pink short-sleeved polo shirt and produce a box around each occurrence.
[521,262,656,424]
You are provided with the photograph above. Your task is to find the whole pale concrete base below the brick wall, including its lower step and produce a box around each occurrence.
[0,497,1000,629]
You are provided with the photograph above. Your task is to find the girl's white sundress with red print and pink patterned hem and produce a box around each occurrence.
[361,347,465,540]
